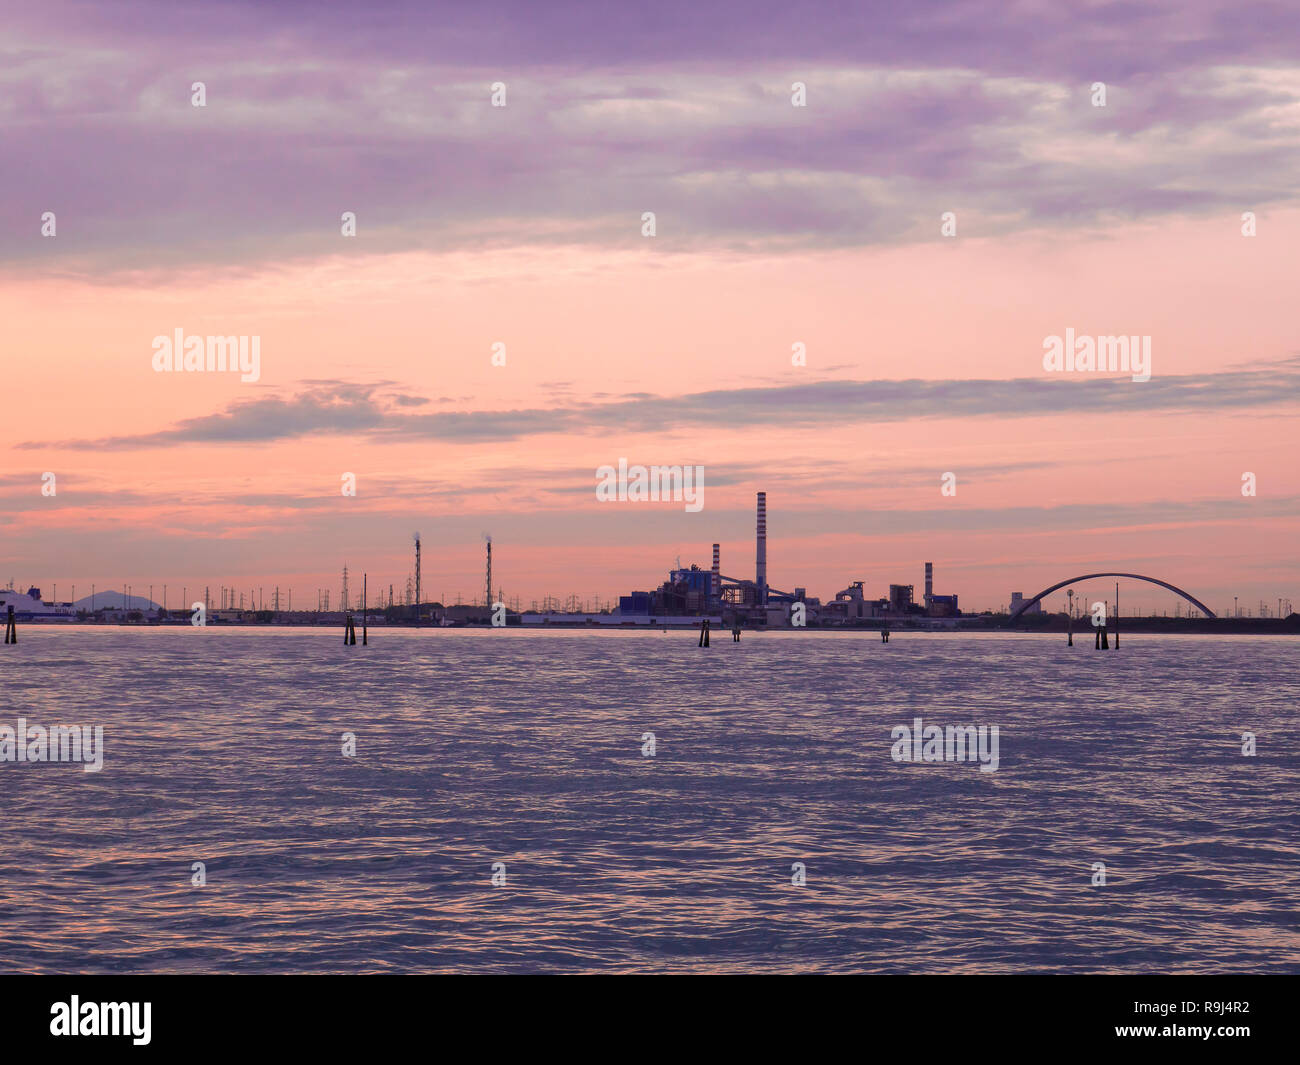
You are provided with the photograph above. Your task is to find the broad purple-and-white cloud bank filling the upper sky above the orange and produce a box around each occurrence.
[0,0,1300,274]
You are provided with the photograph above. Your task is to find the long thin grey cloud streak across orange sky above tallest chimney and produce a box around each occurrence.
[27,360,1300,450]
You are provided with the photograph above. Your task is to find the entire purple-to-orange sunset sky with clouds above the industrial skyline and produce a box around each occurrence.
[0,0,1300,612]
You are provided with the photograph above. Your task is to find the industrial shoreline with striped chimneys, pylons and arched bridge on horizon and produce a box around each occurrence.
[10,492,1300,633]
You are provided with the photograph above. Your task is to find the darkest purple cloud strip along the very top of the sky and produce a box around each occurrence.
[9,0,1295,75]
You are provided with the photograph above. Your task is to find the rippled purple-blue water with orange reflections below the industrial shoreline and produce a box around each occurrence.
[0,625,1300,973]
